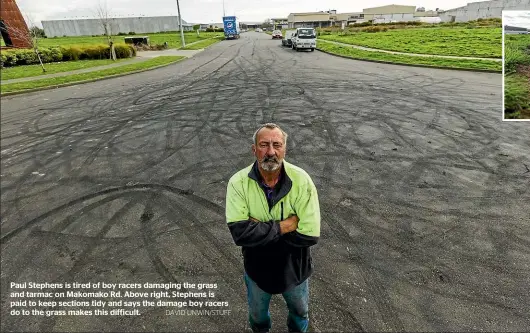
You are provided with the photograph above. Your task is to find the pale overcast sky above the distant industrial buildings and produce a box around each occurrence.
[17,0,477,26]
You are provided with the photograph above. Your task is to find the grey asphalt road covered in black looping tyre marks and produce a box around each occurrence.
[0,33,530,332]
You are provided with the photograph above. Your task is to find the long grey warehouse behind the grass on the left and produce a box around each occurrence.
[42,16,193,37]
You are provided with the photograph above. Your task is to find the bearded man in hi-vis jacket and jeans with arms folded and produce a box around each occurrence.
[226,123,320,332]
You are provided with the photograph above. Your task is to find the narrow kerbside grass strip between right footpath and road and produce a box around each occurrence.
[317,40,502,72]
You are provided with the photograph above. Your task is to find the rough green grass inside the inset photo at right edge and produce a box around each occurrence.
[504,35,530,119]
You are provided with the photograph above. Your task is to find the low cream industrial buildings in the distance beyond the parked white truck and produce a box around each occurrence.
[288,5,438,28]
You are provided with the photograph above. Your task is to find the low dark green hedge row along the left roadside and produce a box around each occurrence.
[0,44,136,67]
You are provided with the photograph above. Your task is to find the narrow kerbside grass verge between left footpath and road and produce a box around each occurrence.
[1,56,185,94]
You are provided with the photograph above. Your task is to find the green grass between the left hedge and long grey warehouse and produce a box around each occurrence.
[39,32,223,48]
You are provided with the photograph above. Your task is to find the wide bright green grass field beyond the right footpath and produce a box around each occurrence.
[319,27,502,58]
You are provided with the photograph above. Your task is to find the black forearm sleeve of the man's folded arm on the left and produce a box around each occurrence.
[228,220,280,247]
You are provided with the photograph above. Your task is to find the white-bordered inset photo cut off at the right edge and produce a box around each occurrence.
[502,10,530,121]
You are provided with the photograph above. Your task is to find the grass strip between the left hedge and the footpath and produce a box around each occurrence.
[2,59,130,80]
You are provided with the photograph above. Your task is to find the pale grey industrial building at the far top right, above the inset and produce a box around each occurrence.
[440,0,530,22]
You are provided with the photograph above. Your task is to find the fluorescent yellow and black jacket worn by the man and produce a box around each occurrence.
[226,160,320,294]
